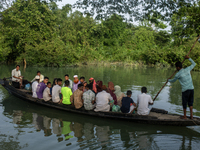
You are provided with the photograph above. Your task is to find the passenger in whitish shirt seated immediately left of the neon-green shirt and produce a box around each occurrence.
[52,78,62,103]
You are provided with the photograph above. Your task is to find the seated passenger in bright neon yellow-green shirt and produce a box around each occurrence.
[61,80,72,105]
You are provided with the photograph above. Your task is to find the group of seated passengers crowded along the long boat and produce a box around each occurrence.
[12,65,153,115]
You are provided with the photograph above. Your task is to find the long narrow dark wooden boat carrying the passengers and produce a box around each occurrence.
[0,79,200,126]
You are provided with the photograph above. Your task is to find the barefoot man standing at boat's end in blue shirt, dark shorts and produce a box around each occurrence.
[168,55,196,119]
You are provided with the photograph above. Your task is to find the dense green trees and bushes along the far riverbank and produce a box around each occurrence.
[0,0,200,70]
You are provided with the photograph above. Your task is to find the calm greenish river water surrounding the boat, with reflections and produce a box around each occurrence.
[0,65,200,150]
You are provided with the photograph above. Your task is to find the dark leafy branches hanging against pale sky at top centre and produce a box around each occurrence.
[75,0,193,21]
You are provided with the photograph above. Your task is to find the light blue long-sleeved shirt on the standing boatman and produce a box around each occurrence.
[168,58,196,92]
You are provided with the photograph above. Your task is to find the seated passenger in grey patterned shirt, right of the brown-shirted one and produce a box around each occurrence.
[83,85,95,110]
